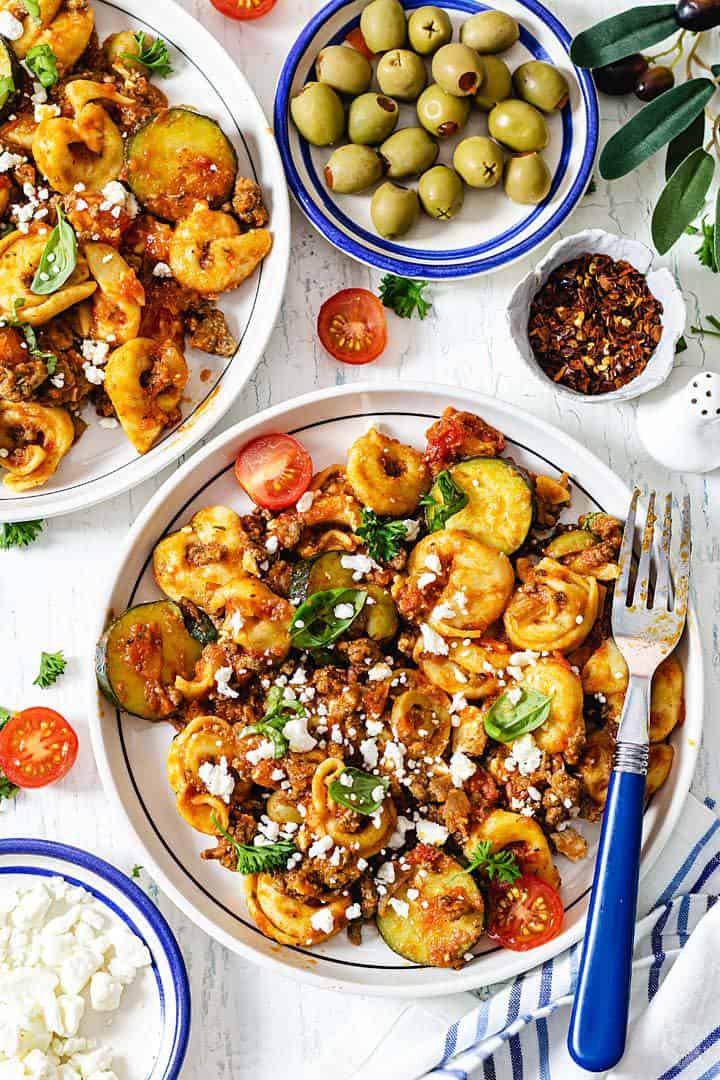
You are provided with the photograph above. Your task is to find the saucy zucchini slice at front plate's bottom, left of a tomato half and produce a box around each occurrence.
[377,845,485,968]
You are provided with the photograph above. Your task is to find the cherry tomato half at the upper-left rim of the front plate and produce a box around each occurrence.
[235,433,313,510]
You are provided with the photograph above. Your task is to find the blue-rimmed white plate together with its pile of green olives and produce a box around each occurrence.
[274,0,598,279]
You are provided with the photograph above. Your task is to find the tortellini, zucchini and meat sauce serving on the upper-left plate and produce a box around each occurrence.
[0,0,272,492]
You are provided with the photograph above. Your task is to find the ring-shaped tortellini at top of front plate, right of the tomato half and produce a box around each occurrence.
[348,428,431,517]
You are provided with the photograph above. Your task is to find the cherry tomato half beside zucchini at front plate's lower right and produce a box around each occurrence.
[487,874,565,953]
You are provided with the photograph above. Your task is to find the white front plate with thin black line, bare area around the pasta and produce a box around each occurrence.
[87,383,703,996]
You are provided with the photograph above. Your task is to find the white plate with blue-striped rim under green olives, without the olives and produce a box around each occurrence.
[274,0,599,280]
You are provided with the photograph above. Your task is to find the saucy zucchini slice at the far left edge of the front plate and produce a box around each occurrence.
[95,600,203,720]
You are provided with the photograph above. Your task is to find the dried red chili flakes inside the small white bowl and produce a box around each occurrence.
[528,255,663,394]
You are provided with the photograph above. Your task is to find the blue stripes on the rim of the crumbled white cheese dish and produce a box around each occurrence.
[0,839,190,1080]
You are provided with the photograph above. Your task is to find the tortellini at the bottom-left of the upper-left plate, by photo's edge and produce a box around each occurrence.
[0,401,74,491]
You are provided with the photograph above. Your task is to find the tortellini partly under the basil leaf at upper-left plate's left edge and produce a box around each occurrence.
[0,227,97,326]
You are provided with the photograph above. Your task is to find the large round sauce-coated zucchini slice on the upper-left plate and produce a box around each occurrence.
[125,108,237,221]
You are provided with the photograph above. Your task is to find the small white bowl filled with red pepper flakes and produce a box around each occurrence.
[507,229,687,404]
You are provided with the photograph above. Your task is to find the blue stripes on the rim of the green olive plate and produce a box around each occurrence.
[273,0,599,279]
